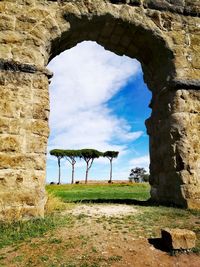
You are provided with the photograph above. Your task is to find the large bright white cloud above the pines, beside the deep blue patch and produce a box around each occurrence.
[49,42,143,152]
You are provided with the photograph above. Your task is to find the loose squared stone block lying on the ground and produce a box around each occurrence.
[161,228,196,250]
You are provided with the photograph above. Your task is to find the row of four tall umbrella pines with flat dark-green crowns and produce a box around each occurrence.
[50,149,119,184]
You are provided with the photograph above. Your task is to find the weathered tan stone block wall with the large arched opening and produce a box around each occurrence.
[0,0,200,219]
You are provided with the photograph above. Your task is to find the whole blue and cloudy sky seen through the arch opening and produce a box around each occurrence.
[46,41,151,183]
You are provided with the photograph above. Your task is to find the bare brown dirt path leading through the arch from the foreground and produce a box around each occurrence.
[0,204,200,267]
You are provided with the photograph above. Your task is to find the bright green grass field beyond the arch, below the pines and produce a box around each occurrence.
[46,183,150,202]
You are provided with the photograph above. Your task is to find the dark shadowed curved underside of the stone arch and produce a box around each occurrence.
[50,9,175,89]
